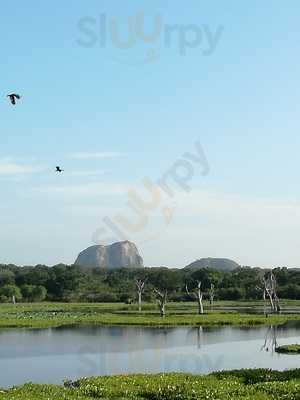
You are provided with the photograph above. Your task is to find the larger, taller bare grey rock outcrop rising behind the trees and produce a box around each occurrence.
[75,241,144,269]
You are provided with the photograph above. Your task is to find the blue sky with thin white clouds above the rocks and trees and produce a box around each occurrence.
[0,0,300,267]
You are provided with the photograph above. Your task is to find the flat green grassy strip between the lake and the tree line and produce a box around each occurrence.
[0,303,300,328]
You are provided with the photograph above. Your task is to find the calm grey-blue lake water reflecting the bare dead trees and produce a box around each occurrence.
[0,322,300,387]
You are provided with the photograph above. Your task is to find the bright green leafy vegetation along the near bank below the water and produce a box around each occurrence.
[0,369,300,400]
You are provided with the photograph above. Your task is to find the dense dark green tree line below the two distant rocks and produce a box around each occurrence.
[0,264,300,304]
